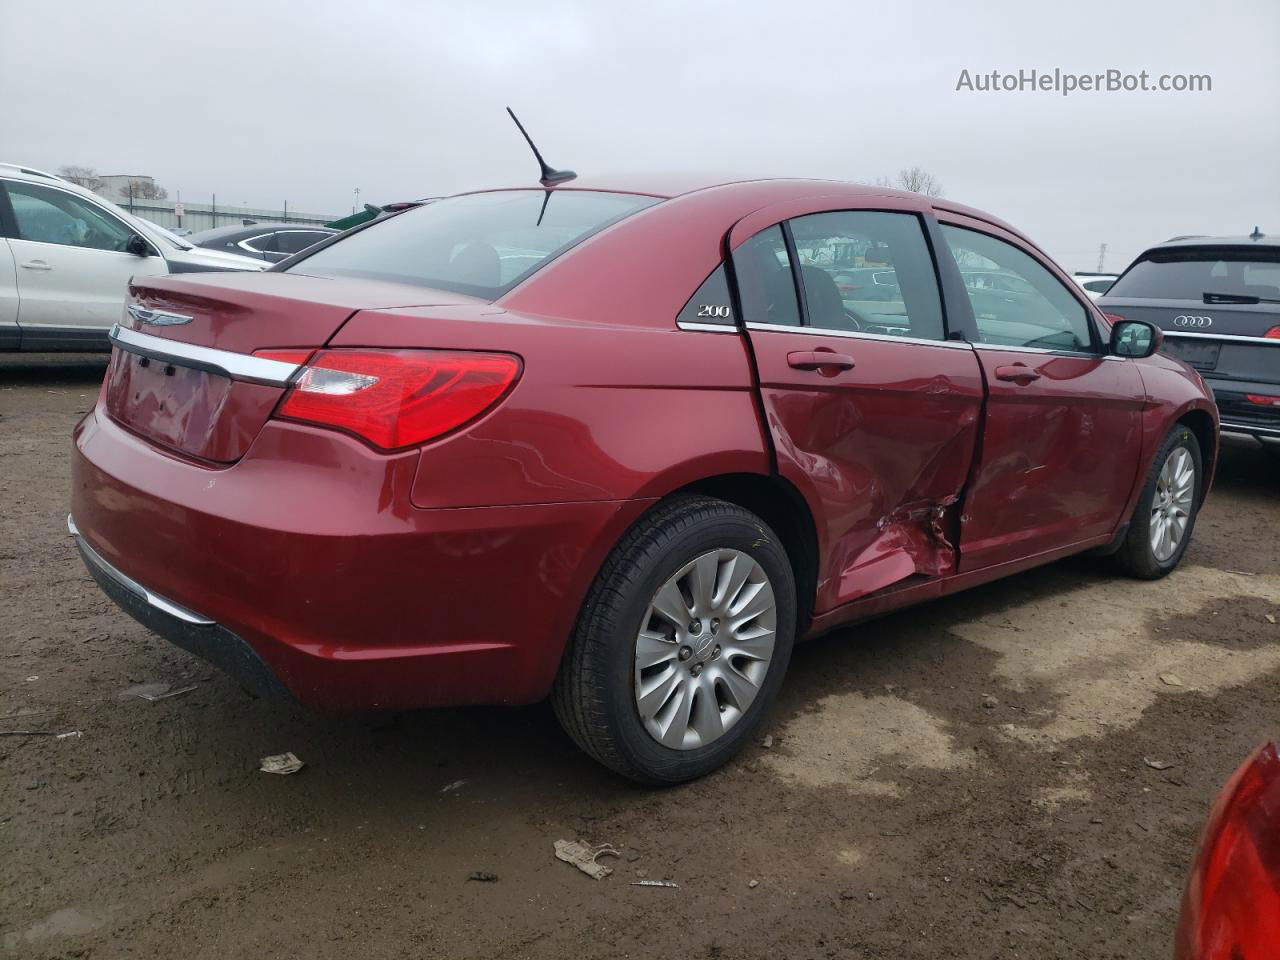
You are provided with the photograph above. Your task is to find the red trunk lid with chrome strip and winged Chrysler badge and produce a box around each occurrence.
[104,273,476,465]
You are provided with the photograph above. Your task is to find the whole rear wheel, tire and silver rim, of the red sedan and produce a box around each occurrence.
[553,497,796,783]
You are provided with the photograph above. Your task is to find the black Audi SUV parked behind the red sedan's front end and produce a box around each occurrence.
[1098,236,1280,449]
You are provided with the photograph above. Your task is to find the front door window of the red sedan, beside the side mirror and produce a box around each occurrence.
[942,224,1094,352]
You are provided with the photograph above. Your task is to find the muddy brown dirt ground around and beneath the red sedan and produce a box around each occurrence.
[0,357,1280,960]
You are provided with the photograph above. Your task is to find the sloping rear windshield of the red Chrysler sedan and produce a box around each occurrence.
[289,189,658,300]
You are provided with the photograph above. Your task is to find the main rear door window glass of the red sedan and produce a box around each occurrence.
[790,210,945,340]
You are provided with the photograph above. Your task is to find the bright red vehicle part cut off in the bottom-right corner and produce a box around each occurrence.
[1174,742,1280,960]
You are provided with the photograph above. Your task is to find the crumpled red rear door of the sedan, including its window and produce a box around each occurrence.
[730,198,983,613]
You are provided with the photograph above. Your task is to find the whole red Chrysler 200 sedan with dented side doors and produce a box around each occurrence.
[70,180,1217,782]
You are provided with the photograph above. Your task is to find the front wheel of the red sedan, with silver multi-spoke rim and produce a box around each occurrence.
[1116,424,1203,580]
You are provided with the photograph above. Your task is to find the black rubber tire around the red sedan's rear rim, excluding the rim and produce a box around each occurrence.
[552,495,796,786]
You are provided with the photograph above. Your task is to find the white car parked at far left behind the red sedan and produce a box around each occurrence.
[0,164,269,351]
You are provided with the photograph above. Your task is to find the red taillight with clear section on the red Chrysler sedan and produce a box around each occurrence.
[264,349,520,451]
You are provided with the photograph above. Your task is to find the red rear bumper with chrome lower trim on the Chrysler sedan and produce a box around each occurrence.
[72,407,650,709]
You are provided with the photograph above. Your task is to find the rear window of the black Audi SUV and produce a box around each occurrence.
[1107,248,1280,300]
